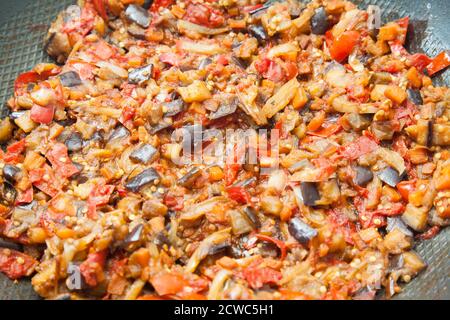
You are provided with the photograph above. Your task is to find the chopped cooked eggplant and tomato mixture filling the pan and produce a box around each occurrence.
[0,0,450,300]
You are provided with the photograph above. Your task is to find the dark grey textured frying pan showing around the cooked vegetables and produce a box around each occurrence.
[0,0,450,300]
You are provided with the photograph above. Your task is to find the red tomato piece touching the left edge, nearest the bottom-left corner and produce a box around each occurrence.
[0,248,38,280]
